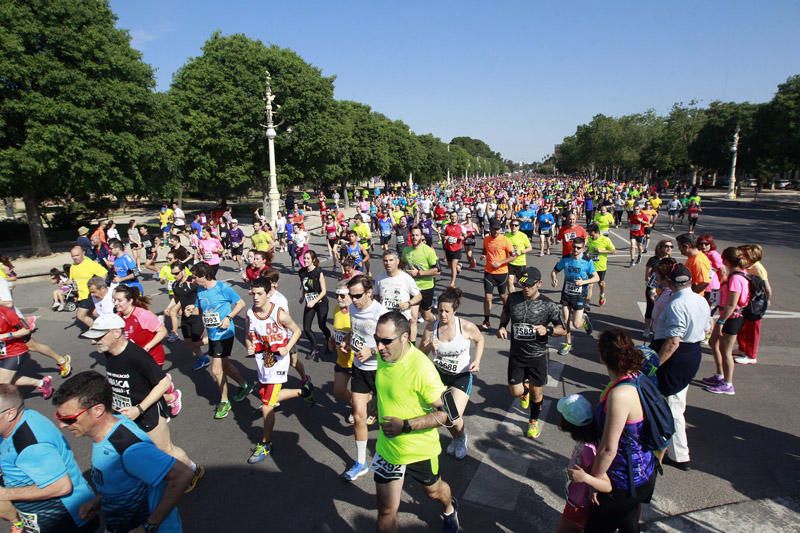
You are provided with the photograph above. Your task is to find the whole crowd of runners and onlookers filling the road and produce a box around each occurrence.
[0,176,771,532]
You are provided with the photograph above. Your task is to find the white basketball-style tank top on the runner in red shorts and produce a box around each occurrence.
[247,303,291,384]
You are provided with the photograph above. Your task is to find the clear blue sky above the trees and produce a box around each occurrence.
[111,0,800,161]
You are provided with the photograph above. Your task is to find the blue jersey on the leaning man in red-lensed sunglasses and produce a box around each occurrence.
[92,416,183,533]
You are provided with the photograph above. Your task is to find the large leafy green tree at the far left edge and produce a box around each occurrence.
[0,0,166,255]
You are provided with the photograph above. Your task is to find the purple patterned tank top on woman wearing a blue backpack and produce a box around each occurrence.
[595,376,655,489]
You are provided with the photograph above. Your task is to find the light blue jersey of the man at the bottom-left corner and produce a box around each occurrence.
[0,409,94,533]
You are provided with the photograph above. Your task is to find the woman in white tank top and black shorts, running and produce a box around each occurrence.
[420,287,484,459]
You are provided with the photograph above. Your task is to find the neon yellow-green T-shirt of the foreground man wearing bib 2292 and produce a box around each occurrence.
[375,346,446,465]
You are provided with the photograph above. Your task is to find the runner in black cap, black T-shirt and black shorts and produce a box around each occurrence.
[497,266,574,439]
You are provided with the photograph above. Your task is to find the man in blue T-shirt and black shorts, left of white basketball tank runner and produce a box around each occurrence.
[189,263,254,420]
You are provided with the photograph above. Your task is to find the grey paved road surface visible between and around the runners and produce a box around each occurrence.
[7,193,800,532]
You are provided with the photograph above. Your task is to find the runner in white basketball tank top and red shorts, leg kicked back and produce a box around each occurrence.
[246,278,313,464]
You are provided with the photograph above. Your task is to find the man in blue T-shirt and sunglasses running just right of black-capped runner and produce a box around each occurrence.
[550,237,600,355]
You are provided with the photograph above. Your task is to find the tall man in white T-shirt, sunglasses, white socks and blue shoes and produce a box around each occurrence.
[342,274,387,481]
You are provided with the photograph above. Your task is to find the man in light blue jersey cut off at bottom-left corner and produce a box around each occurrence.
[0,384,99,533]
